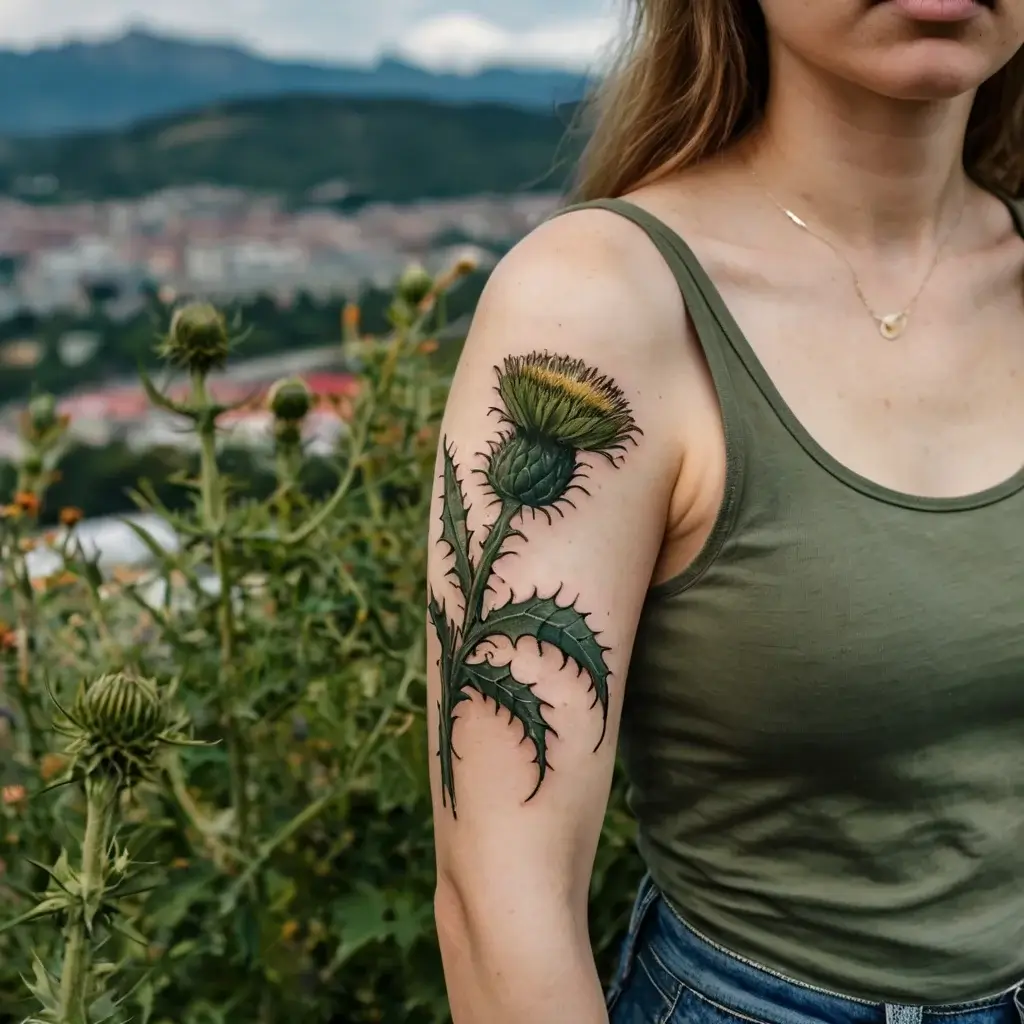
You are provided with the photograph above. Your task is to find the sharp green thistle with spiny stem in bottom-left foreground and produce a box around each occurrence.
[5,672,190,1024]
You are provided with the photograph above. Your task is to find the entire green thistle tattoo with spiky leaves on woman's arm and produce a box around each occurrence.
[429,352,642,815]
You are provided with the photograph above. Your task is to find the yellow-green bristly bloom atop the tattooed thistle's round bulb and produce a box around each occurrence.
[498,352,640,455]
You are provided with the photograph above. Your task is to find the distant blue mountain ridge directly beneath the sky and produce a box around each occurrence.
[0,30,586,135]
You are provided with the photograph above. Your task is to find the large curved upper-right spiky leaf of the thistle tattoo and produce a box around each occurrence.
[466,594,610,746]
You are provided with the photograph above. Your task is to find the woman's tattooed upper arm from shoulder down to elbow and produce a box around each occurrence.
[428,214,678,906]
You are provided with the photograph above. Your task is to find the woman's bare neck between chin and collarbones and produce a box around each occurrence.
[743,51,973,251]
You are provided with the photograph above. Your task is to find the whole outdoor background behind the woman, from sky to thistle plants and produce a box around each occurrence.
[0,0,640,1024]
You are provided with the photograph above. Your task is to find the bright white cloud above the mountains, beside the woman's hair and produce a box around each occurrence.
[397,12,617,72]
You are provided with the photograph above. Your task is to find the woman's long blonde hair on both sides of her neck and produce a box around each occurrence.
[574,0,1024,200]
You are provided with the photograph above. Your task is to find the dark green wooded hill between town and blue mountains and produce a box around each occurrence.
[0,95,578,203]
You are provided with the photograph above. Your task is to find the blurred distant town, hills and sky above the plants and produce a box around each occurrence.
[0,0,614,517]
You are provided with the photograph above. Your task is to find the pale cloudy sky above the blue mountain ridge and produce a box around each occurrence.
[0,0,625,71]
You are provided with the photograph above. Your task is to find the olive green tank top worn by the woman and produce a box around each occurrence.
[570,201,1024,1006]
